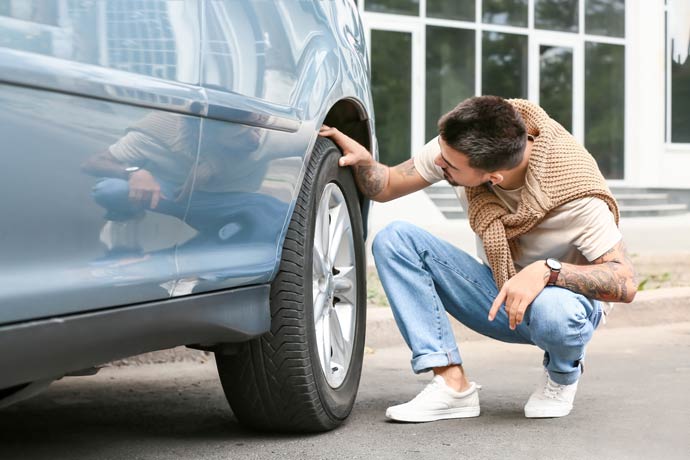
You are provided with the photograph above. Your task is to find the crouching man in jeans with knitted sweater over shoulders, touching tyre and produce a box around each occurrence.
[320,96,636,422]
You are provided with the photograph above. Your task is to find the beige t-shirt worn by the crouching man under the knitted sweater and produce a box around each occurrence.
[414,138,623,271]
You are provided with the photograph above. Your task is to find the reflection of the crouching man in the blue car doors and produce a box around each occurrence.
[82,112,287,253]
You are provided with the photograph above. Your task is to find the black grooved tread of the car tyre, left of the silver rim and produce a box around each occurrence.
[216,138,360,432]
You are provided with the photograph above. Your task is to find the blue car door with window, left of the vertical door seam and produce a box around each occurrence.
[0,0,206,324]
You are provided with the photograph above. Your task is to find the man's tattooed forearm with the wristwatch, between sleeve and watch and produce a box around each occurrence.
[556,241,637,302]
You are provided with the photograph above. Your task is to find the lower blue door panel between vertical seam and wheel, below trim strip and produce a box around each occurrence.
[176,120,296,295]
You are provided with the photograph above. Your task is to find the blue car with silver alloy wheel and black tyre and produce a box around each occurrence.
[0,0,377,432]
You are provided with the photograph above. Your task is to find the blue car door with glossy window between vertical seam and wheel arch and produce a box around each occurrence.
[172,0,338,295]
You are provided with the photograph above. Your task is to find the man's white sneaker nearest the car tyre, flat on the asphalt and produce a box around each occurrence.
[386,375,481,422]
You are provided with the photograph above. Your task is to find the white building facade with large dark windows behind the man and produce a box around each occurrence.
[358,0,690,189]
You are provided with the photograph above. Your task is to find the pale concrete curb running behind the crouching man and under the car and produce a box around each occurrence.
[107,287,690,366]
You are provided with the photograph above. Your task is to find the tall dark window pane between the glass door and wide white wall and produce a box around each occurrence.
[584,42,625,179]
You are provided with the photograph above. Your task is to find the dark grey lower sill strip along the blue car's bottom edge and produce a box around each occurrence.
[0,285,270,388]
